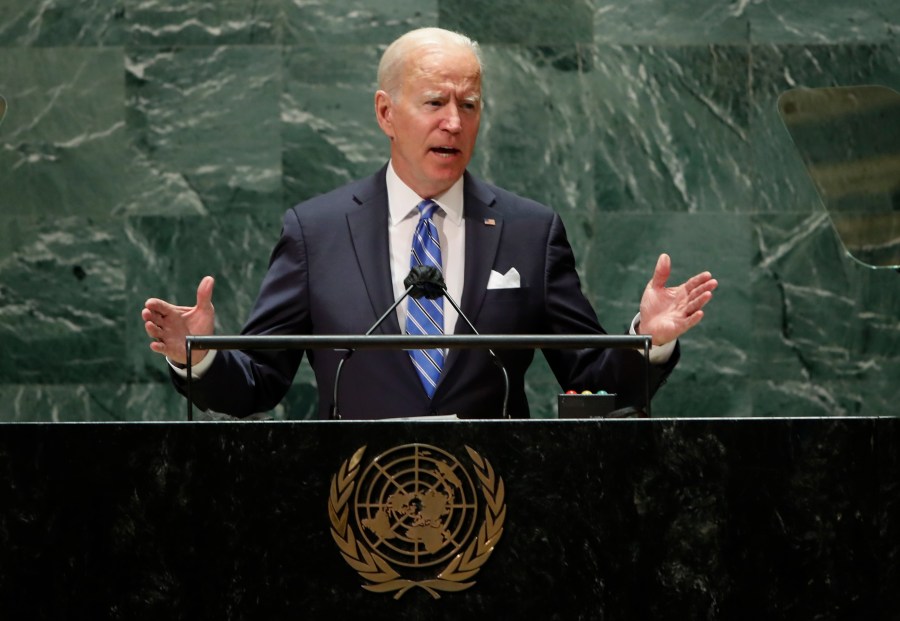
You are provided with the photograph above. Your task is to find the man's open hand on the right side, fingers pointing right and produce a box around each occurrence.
[638,254,719,345]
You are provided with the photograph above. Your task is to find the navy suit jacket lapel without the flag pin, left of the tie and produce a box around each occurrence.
[347,169,400,334]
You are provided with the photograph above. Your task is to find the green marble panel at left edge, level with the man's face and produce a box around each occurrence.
[0,48,126,216]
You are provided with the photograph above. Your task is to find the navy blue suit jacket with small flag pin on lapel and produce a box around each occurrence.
[173,169,678,419]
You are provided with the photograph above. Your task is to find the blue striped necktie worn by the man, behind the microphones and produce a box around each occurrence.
[406,200,444,399]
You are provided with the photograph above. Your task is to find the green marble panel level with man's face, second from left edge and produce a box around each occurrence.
[126,46,281,214]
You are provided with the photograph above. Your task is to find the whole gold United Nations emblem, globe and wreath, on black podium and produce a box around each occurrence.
[328,444,506,599]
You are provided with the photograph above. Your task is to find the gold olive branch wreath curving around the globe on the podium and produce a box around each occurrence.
[328,446,506,599]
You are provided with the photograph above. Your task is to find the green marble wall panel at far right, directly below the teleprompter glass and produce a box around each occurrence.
[752,212,900,416]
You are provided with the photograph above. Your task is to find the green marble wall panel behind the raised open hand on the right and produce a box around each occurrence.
[579,213,755,417]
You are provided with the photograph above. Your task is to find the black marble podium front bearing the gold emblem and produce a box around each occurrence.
[0,418,900,620]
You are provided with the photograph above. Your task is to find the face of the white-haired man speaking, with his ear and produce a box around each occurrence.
[375,47,481,198]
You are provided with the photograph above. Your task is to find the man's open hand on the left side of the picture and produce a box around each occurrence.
[141,276,216,365]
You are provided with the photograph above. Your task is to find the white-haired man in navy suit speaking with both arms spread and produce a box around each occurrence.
[142,28,717,419]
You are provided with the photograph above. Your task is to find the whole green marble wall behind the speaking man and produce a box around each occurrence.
[0,0,900,421]
